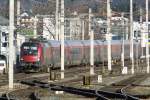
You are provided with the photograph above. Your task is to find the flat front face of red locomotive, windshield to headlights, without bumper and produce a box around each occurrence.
[20,42,40,65]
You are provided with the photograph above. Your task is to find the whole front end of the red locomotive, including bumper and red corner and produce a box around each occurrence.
[20,42,42,69]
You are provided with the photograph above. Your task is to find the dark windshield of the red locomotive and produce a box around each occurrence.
[22,43,38,55]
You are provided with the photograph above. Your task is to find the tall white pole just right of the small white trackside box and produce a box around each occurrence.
[130,0,134,74]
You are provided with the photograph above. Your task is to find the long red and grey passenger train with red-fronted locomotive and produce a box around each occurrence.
[20,40,141,69]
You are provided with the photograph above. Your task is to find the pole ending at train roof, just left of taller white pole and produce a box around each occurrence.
[55,0,59,40]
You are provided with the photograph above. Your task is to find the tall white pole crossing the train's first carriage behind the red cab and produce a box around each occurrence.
[60,0,65,79]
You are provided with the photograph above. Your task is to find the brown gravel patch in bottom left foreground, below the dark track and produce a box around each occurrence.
[11,87,95,100]
